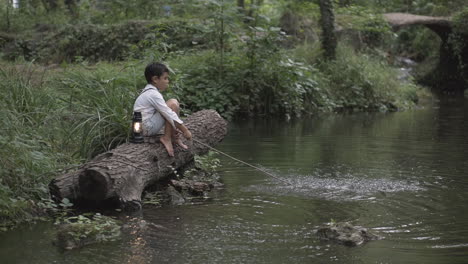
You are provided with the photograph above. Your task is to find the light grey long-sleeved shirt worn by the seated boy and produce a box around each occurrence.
[133,84,184,128]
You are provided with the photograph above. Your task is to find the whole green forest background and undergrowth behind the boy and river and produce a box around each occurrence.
[0,0,468,230]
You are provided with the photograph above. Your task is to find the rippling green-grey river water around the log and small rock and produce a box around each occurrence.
[0,99,468,263]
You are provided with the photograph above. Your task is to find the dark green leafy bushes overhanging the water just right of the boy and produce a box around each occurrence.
[170,48,325,118]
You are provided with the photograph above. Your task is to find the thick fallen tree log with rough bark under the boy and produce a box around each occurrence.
[49,110,227,210]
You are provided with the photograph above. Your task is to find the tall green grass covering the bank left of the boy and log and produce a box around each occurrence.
[0,60,142,229]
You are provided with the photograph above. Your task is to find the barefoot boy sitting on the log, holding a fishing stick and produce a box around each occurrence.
[133,63,192,157]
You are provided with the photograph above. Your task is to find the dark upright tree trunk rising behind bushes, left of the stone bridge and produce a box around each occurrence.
[319,0,337,60]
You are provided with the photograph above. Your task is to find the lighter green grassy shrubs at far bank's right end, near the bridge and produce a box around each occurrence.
[323,46,417,111]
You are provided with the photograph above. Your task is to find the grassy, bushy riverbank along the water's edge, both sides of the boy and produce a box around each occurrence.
[0,47,423,229]
